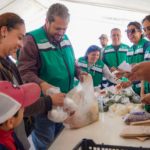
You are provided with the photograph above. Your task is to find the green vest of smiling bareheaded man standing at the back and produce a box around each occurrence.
[104,43,129,82]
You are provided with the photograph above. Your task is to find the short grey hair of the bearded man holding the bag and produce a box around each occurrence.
[46,3,70,22]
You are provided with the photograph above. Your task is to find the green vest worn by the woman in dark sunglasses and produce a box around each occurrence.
[126,38,148,94]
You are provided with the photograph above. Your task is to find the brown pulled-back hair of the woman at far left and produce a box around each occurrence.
[0,13,25,38]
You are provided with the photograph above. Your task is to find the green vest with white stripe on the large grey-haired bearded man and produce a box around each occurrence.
[28,27,75,93]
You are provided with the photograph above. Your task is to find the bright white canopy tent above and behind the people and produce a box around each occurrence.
[0,0,150,57]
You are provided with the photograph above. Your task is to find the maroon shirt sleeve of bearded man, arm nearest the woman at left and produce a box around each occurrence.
[18,35,44,85]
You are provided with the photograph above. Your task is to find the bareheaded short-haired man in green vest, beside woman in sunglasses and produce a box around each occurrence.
[102,28,132,87]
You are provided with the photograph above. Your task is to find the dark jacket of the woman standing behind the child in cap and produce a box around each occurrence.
[0,56,52,150]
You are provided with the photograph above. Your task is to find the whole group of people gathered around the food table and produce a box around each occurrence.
[0,3,150,150]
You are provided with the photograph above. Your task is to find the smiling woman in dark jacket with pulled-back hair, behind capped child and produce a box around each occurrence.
[0,13,65,150]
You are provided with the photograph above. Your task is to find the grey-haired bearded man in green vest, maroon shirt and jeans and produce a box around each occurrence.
[18,3,87,150]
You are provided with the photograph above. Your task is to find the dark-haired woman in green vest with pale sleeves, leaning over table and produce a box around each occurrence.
[75,45,123,87]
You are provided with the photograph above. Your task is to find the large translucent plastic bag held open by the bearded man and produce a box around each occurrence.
[63,74,99,128]
